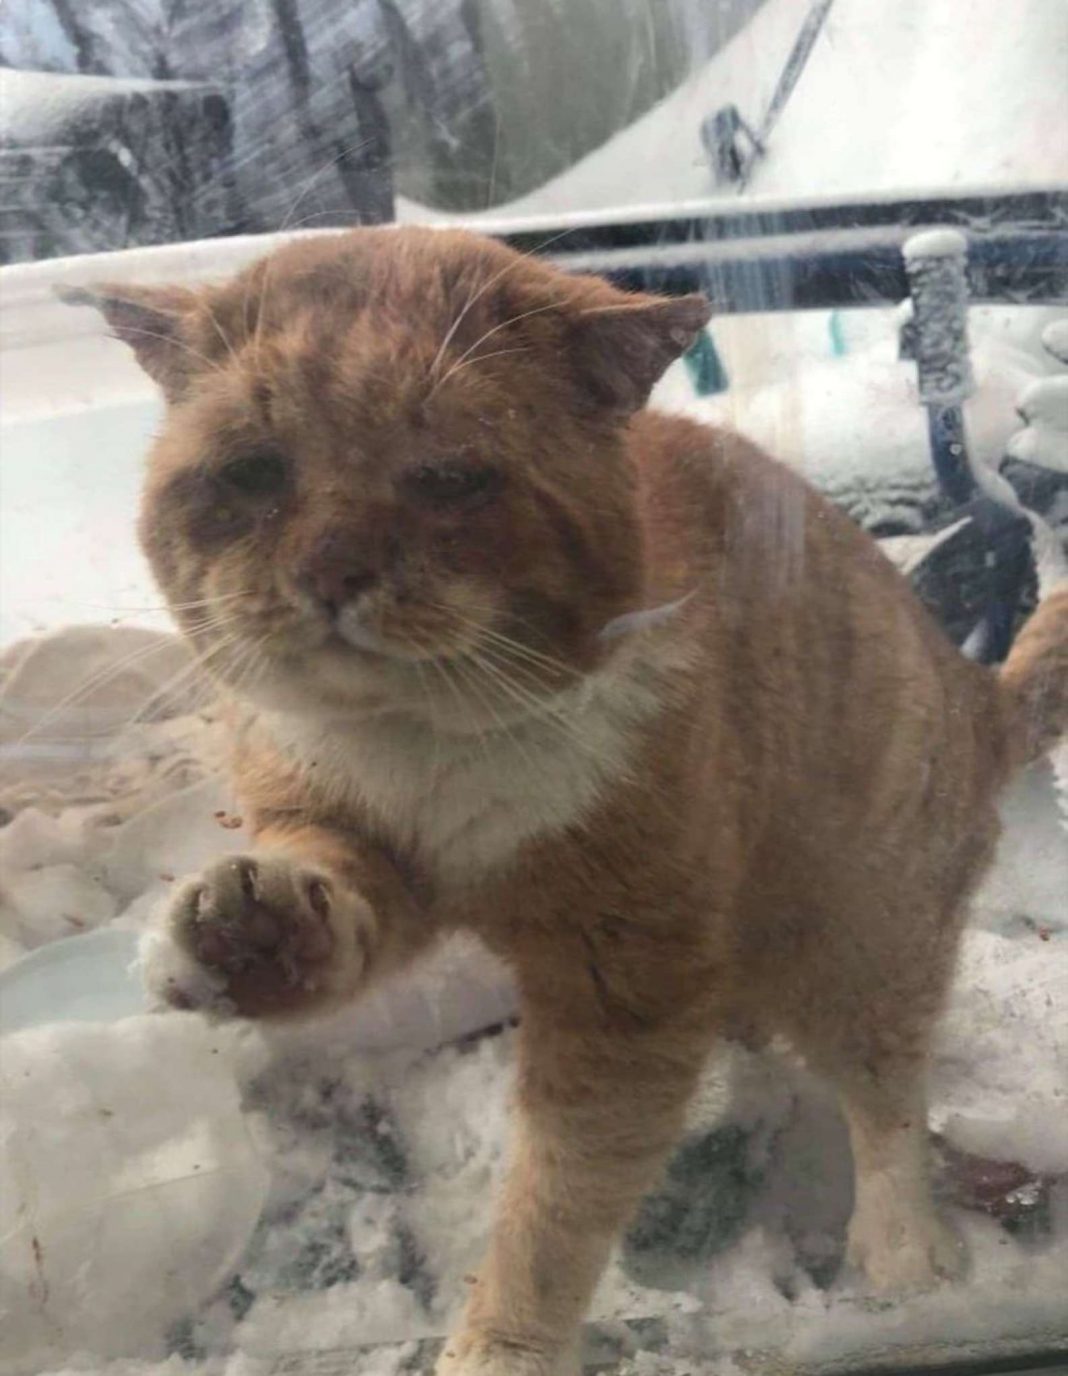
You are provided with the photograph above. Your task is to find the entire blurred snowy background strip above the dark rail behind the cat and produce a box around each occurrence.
[0,0,1068,261]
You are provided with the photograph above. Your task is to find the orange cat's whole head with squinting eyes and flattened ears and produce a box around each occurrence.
[72,230,707,729]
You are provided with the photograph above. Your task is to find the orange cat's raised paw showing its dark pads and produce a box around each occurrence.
[156,854,372,1017]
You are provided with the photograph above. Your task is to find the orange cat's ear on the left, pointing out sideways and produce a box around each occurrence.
[55,282,198,400]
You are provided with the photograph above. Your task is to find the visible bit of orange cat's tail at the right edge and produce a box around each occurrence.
[999,583,1068,765]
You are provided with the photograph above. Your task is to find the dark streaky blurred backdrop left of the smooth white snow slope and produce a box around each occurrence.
[0,0,760,261]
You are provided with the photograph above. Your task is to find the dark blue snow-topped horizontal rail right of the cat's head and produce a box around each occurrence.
[503,187,1068,314]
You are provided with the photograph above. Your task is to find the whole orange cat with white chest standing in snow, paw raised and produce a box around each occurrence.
[74,228,1068,1376]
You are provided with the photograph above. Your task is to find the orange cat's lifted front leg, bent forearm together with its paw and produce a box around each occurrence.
[147,827,429,1017]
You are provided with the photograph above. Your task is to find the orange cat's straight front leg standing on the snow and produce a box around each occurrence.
[438,1002,712,1376]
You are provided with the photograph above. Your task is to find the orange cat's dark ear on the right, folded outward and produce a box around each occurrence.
[570,293,712,413]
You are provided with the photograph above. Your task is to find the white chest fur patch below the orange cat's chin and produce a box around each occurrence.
[266,646,662,879]
